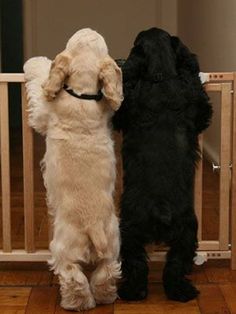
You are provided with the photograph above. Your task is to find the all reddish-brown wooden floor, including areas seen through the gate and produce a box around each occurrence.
[0,127,231,314]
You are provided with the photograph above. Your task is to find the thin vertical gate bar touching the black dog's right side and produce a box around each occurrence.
[194,135,203,241]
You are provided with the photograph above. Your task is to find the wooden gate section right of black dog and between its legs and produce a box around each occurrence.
[149,72,236,270]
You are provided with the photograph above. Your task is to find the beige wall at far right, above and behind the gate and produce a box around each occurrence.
[178,0,236,161]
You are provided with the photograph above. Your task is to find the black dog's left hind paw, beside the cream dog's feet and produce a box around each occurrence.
[118,282,148,301]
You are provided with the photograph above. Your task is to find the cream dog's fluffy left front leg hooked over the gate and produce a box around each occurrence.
[24,57,52,135]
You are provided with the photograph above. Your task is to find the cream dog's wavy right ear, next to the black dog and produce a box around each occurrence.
[99,56,123,111]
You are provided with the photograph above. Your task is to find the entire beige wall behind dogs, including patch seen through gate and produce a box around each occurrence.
[23,0,236,164]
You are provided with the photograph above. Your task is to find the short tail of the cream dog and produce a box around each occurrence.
[88,222,108,258]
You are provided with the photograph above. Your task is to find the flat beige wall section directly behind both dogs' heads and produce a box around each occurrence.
[23,0,177,59]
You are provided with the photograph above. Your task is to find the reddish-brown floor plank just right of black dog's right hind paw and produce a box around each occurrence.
[197,284,230,314]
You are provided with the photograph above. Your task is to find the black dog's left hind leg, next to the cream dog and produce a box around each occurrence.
[118,223,148,300]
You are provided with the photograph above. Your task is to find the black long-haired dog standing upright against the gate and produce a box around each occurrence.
[114,28,212,302]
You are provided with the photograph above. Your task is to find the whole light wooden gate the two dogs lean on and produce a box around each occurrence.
[0,72,236,269]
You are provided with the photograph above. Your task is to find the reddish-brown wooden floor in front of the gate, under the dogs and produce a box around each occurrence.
[0,261,236,314]
